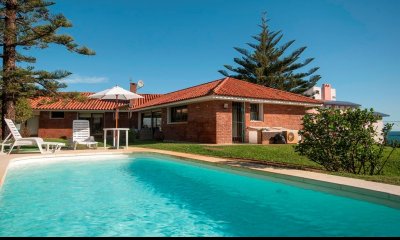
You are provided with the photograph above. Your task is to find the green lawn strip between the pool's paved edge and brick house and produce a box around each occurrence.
[130,141,400,185]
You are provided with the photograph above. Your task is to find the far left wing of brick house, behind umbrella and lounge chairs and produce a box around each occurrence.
[25,88,161,139]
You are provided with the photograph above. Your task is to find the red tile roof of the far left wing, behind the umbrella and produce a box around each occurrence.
[30,92,162,110]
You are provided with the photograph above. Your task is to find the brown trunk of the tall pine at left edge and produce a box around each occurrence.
[1,0,17,139]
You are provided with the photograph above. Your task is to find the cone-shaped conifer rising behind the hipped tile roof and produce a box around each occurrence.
[218,13,321,94]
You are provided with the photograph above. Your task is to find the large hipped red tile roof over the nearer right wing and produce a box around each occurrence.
[135,77,322,109]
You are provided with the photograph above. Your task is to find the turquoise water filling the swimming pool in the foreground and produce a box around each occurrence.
[0,155,400,236]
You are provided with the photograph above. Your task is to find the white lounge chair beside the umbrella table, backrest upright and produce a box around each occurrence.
[72,120,98,150]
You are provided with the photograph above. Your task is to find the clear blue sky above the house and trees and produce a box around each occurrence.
[28,0,400,129]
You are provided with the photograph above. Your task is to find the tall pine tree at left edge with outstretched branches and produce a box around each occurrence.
[0,0,95,138]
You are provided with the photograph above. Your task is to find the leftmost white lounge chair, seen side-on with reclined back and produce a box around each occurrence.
[2,119,65,154]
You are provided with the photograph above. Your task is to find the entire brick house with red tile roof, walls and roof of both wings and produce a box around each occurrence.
[31,77,322,144]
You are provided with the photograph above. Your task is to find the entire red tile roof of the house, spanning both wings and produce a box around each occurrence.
[31,78,322,110]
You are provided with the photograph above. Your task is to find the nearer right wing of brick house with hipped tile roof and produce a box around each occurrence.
[132,78,322,144]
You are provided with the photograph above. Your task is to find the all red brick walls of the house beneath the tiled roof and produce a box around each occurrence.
[38,100,306,144]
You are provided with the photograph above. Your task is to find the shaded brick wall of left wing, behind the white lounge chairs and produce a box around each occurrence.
[38,112,77,138]
